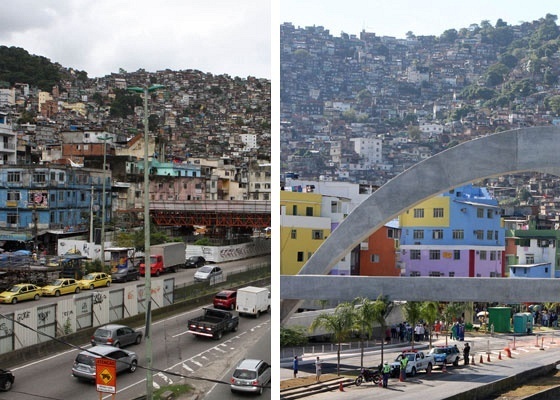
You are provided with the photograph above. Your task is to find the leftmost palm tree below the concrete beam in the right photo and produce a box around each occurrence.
[309,302,354,375]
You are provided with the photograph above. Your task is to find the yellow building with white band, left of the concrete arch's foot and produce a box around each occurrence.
[280,191,331,275]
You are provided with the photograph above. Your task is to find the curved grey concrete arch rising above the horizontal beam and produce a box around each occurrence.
[280,126,560,319]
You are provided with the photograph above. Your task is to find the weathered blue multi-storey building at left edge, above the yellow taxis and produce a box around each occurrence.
[0,164,107,253]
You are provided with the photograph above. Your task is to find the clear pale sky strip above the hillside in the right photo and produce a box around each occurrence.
[280,0,560,38]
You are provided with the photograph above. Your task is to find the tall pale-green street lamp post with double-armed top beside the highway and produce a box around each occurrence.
[128,85,164,400]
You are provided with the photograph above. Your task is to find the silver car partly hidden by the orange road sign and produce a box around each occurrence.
[72,346,138,380]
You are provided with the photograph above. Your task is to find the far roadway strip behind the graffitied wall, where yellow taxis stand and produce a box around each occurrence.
[0,255,270,315]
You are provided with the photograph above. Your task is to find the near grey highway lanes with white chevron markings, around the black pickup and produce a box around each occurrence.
[7,300,270,400]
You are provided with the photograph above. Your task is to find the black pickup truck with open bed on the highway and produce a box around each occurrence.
[187,308,239,339]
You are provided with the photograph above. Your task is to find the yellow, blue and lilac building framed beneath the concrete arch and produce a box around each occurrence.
[399,185,505,277]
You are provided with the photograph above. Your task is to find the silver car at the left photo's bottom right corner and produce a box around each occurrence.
[230,359,271,394]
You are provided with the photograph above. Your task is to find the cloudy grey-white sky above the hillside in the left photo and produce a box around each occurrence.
[0,0,271,78]
